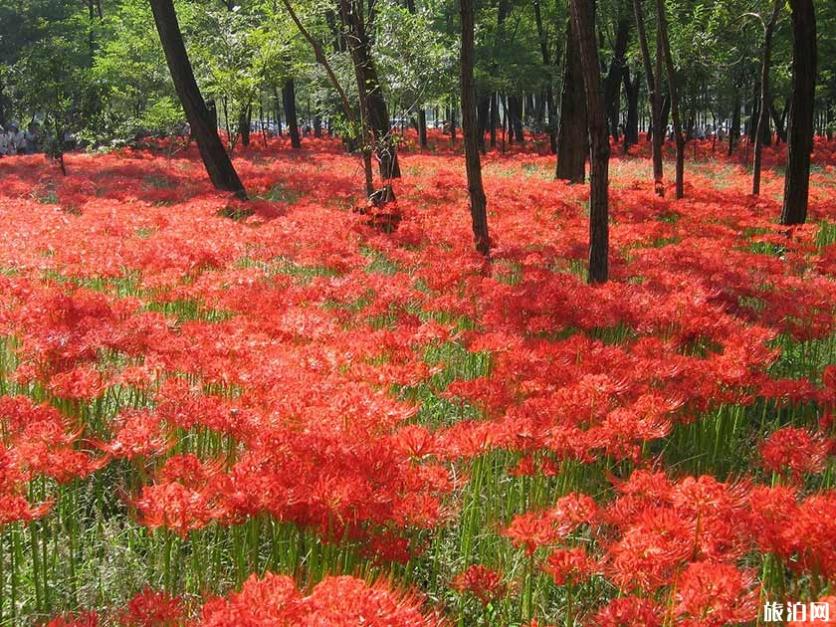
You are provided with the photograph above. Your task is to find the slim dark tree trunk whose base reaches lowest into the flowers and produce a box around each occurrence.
[569,0,610,283]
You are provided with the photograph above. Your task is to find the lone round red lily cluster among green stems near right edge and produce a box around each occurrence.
[761,427,830,481]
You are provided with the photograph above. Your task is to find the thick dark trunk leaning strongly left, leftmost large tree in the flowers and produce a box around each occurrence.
[151,0,247,198]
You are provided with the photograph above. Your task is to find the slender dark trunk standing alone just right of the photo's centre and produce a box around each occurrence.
[459,0,490,256]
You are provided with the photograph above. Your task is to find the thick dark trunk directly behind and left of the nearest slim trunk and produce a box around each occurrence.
[557,19,589,183]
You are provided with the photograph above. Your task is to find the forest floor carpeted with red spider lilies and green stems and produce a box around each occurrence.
[0,137,836,626]
